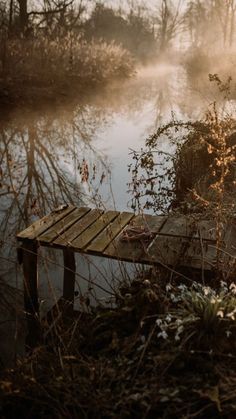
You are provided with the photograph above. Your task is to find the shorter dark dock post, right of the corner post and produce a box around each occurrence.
[63,249,76,312]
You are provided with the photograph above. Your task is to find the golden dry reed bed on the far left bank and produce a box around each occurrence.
[0,34,134,106]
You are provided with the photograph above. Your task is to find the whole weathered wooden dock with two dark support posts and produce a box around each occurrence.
[17,205,236,348]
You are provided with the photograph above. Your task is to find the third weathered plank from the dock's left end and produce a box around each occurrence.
[53,209,103,247]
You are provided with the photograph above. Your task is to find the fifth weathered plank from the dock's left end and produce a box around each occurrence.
[86,212,134,253]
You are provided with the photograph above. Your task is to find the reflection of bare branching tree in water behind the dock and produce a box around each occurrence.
[0,107,110,241]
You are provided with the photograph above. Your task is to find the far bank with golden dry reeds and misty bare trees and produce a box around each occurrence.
[0,0,236,103]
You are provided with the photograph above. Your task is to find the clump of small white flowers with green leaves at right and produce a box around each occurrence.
[156,281,236,350]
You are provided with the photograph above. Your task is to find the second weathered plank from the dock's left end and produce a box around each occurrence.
[37,207,90,243]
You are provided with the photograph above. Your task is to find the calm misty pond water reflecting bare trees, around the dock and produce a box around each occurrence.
[0,61,205,364]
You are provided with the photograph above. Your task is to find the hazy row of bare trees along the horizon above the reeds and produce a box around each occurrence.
[0,0,236,60]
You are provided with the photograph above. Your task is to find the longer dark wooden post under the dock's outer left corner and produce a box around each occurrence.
[21,241,40,348]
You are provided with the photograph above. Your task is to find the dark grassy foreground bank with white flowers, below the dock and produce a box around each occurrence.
[0,272,236,419]
